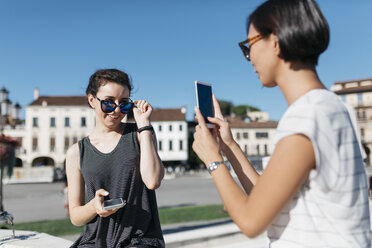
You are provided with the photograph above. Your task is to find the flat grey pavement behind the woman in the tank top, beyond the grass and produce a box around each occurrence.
[4,170,221,222]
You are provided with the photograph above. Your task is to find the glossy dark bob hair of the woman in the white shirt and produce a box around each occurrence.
[247,0,329,65]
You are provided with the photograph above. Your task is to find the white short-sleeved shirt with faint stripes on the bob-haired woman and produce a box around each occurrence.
[268,89,371,248]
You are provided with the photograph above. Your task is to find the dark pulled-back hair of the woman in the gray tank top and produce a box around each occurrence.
[85,69,132,96]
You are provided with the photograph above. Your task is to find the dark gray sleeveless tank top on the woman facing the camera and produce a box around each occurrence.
[71,123,165,248]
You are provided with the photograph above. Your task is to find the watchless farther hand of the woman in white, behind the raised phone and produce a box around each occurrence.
[208,94,234,151]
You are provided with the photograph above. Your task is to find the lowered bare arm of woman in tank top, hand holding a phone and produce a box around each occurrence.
[66,144,118,226]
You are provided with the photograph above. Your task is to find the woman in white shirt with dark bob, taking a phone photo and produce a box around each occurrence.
[193,0,371,248]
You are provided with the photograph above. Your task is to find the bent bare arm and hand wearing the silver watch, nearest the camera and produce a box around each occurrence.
[193,109,315,237]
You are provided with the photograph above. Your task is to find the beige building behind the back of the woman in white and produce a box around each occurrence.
[331,78,372,165]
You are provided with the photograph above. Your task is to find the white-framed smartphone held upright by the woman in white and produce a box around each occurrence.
[195,81,214,128]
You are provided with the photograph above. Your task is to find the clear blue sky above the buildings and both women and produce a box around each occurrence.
[0,0,372,120]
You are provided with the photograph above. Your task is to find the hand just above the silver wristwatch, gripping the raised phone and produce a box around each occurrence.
[192,107,223,166]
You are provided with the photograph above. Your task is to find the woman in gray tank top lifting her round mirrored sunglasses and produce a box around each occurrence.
[66,69,164,248]
